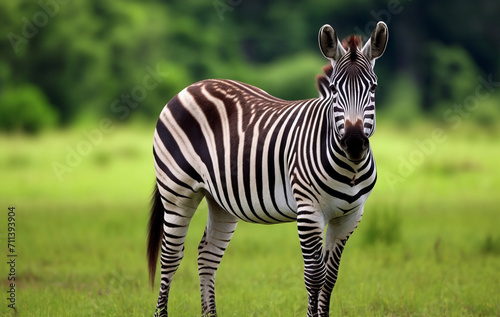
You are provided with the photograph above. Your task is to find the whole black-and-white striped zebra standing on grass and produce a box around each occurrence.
[147,22,388,317]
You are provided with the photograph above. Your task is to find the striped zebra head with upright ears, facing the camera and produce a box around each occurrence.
[319,22,389,161]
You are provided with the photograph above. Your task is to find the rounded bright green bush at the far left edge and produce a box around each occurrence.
[0,85,58,133]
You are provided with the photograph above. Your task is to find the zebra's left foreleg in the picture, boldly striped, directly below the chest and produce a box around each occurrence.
[297,212,326,317]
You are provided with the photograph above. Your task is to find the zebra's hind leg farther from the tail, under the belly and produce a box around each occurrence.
[198,197,238,317]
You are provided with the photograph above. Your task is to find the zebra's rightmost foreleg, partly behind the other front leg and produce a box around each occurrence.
[318,210,363,317]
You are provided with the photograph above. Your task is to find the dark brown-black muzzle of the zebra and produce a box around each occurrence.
[340,120,370,162]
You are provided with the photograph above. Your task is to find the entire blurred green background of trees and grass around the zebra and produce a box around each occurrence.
[0,0,500,316]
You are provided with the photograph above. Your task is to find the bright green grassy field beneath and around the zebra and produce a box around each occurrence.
[0,122,500,317]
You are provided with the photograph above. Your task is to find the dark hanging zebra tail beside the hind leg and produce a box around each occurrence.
[147,184,164,287]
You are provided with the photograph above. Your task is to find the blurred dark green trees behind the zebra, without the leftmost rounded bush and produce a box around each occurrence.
[0,0,500,130]
